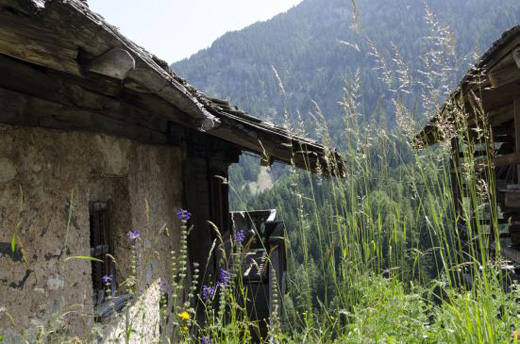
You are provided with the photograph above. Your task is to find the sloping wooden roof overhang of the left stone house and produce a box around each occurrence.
[0,0,343,176]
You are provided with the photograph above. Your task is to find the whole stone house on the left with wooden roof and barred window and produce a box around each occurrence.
[0,0,341,342]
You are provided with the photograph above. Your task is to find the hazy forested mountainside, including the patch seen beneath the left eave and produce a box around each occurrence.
[172,0,520,202]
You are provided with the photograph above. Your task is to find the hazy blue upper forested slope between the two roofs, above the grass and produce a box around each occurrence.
[172,0,520,134]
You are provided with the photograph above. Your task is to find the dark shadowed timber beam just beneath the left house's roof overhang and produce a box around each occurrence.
[0,55,196,128]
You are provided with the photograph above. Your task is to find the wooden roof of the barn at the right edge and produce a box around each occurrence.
[413,26,520,147]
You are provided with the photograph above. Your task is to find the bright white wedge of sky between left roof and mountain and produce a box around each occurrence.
[88,0,301,63]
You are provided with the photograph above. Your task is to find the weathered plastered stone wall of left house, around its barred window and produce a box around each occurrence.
[0,126,182,338]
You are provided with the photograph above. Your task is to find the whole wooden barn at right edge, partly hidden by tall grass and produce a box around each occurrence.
[415,26,520,264]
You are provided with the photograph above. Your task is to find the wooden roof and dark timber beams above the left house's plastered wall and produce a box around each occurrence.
[0,0,341,174]
